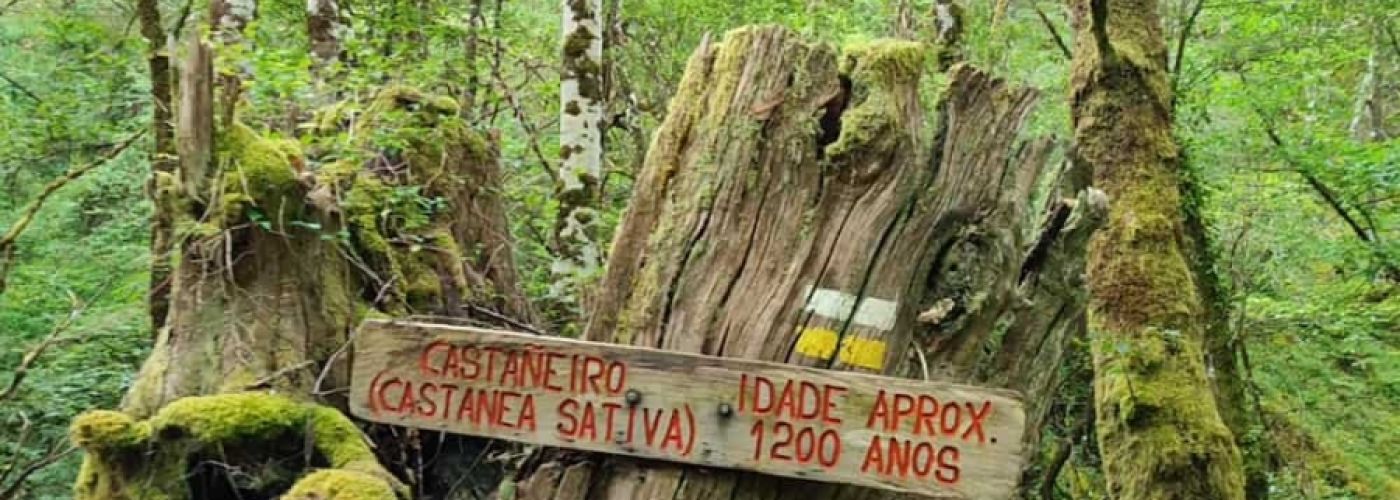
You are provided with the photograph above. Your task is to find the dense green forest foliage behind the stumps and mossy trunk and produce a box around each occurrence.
[0,0,1400,499]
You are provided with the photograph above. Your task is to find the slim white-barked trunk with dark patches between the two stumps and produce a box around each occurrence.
[553,0,603,299]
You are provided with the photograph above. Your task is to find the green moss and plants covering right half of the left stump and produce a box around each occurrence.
[316,87,494,314]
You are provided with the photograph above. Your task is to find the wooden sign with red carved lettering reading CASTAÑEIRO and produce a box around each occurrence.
[350,321,1025,499]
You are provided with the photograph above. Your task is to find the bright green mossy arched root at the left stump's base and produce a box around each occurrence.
[70,392,409,500]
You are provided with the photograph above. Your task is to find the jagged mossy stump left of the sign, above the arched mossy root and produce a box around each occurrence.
[112,73,532,497]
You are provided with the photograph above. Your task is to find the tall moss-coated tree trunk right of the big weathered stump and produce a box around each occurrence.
[1070,0,1243,499]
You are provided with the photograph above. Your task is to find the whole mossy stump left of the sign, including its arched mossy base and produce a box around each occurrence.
[73,36,532,500]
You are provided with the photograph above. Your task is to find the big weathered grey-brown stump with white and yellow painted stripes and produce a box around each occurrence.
[517,28,1103,499]
